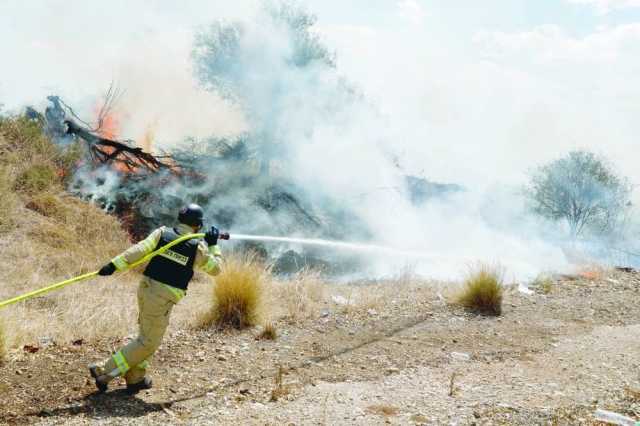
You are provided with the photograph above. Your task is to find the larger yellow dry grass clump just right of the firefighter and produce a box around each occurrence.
[199,257,267,329]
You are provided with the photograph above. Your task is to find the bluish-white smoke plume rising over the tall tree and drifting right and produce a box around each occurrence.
[176,3,568,278]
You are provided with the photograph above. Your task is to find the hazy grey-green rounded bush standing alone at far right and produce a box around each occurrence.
[526,151,631,237]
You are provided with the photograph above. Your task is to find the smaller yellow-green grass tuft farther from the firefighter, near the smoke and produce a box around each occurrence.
[457,266,503,315]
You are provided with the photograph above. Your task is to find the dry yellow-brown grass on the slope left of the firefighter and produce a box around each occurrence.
[0,118,137,347]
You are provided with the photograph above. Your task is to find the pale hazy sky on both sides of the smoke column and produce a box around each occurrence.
[0,0,640,185]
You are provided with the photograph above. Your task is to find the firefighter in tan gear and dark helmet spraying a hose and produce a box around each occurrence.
[89,204,222,394]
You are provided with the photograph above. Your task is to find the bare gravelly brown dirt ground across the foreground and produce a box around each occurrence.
[0,271,640,425]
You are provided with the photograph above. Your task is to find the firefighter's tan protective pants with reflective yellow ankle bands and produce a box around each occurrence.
[100,277,184,384]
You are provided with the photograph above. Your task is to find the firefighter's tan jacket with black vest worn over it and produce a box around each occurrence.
[111,224,222,300]
